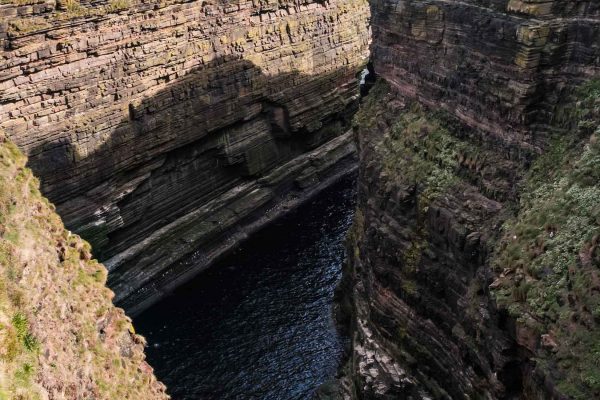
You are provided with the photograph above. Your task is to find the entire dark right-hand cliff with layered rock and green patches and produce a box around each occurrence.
[341,0,600,399]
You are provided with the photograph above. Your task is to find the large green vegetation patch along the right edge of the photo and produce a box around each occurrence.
[492,80,600,399]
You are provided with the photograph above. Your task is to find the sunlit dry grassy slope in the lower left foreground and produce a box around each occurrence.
[0,132,167,400]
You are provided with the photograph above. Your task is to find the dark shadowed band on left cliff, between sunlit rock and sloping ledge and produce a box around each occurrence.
[30,56,366,259]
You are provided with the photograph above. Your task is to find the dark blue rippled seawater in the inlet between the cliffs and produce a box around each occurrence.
[134,178,355,400]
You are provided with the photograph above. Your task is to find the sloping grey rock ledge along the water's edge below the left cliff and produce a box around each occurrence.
[111,132,357,313]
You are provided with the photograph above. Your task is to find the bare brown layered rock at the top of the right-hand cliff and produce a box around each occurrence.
[372,0,600,150]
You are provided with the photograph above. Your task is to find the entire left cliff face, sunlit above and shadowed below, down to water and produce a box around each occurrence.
[0,0,369,307]
